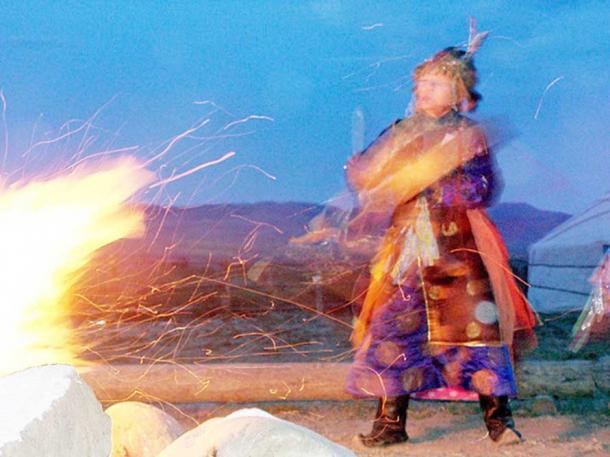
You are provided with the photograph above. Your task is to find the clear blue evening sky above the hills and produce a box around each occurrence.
[0,0,610,213]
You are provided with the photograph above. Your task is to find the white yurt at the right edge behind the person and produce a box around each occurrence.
[528,192,610,313]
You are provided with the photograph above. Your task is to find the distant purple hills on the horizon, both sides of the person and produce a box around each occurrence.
[109,202,570,263]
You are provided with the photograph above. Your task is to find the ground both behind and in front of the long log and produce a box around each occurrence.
[79,258,610,457]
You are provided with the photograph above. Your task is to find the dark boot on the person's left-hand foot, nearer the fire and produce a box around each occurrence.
[358,395,409,447]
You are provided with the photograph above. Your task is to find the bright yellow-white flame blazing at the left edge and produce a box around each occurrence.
[0,158,152,373]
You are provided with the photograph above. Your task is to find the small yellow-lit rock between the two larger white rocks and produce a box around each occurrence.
[106,401,185,457]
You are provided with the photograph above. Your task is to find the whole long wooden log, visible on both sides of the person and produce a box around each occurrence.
[79,360,607,403]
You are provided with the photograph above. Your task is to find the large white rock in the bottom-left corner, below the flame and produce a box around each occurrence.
[0,365,112,457]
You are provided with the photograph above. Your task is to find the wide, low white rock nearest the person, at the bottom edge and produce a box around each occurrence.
[159,409,355,457]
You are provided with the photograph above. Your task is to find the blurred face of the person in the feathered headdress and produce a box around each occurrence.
[415,71,457,117]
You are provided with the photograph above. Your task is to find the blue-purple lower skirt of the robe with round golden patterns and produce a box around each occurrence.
[346,287,517,398]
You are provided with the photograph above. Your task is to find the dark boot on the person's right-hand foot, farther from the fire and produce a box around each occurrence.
[479,395,523,444]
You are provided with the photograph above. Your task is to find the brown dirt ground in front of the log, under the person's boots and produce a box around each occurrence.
[172,401,610,457]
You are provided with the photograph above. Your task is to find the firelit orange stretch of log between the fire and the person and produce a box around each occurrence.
[80,363,351,403]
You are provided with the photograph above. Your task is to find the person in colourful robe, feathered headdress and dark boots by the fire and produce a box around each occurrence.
[346,25,536,446]
